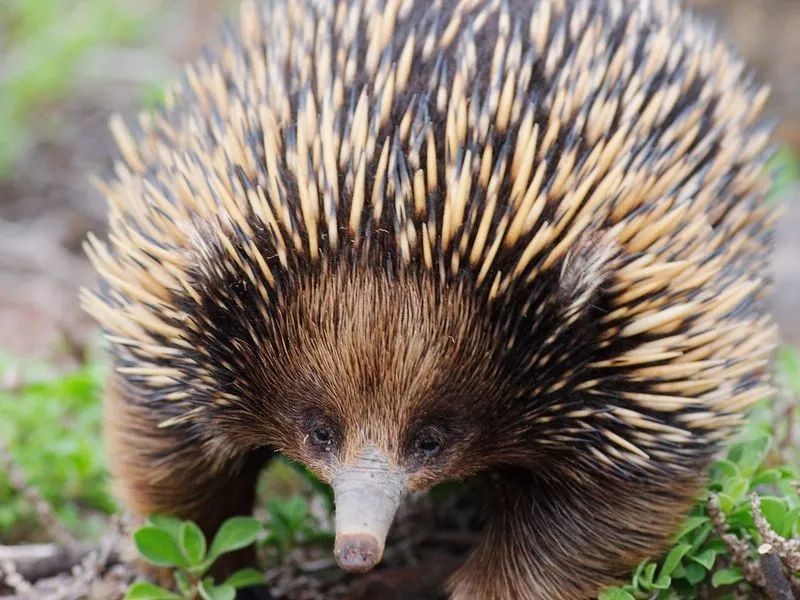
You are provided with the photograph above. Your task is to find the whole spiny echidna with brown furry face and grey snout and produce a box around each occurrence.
[84,0,776,599]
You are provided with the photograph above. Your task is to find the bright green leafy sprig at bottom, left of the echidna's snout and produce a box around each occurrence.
[125,515,264,600]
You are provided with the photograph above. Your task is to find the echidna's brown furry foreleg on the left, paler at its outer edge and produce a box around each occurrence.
[104,380,268,574]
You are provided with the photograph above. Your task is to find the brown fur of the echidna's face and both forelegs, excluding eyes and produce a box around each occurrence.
[106,270,724,599]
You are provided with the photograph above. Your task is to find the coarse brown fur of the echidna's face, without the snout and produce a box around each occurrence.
[196,268,508,489]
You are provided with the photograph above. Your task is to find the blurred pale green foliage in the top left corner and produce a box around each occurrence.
[0,0,152,178]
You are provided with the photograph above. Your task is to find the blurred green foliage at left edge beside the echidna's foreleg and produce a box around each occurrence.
[0,357,116,543]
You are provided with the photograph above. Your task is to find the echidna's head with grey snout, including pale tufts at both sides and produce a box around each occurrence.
[134,220,614,571]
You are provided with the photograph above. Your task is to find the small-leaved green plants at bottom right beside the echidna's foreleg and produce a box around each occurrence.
[599,406,800,600]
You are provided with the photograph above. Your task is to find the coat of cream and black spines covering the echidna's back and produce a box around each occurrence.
[85,0,775,464]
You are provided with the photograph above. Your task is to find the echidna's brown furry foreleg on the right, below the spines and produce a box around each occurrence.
[450,473,701,600]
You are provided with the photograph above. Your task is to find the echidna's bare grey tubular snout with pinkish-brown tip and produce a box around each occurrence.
[332,446,406,573]
